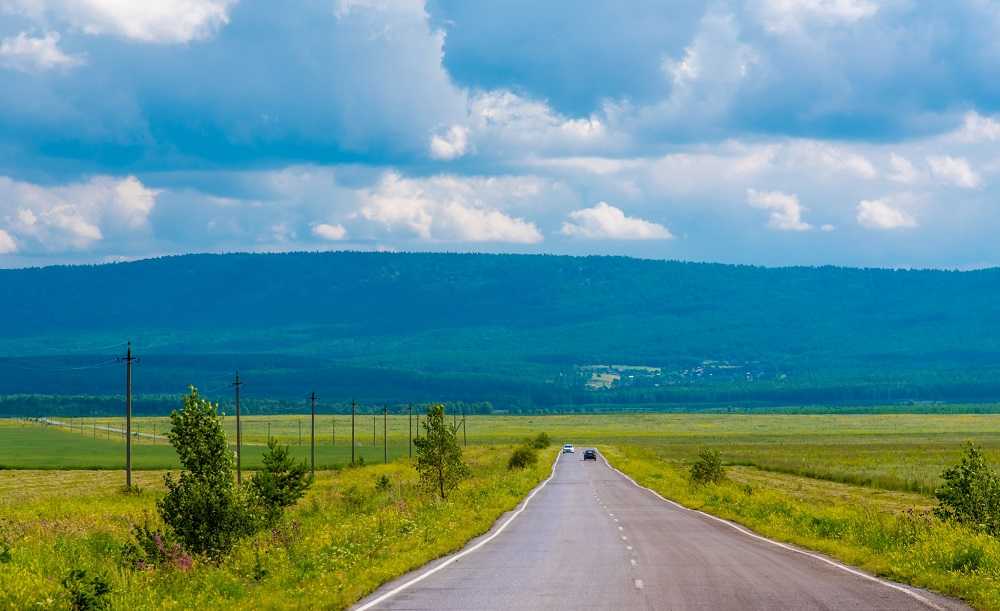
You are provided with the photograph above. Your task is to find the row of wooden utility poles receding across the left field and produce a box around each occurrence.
[119,342,469,488]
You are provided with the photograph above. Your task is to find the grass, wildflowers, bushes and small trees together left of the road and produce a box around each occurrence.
[0,404,548,609]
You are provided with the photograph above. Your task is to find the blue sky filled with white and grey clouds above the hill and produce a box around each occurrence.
[0,0,1000,269]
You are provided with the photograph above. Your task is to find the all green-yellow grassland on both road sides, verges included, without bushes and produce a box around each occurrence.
[0,414,1000,609]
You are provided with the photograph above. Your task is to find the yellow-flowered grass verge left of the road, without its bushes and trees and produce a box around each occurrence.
[0,446,552,610]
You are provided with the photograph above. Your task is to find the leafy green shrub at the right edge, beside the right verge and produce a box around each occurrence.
[934,443,1000,536]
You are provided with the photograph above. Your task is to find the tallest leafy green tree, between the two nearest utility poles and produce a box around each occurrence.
[157,386,255,557]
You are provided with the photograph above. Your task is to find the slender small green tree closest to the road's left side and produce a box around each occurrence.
[413,404,469,499]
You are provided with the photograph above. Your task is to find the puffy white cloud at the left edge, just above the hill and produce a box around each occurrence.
[0,176,158,251]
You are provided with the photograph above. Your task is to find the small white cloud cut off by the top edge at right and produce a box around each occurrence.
[756,0,879,33]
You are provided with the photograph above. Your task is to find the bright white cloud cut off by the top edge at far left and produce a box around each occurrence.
[0,0,237,43]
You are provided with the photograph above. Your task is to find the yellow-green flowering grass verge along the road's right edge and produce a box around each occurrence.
[602,446,1000,609]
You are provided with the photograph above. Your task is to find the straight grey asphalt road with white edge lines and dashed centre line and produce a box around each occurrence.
[356,453,968,611]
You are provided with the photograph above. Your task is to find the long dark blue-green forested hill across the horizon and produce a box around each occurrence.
[0,253,1000,414]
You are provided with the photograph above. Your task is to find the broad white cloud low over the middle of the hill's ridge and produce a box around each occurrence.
[359,172,542,244]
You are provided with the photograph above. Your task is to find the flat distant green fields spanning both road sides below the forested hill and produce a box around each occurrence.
[0,414,1000,494]
